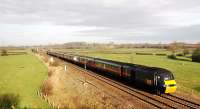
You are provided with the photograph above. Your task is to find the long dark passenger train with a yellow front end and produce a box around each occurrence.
[47,51,177,95]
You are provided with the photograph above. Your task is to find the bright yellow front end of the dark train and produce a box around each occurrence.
[165,80,177,93]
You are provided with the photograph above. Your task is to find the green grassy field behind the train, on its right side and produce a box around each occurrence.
[60,48,200,94]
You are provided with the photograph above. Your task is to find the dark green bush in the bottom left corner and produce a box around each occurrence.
[0,94,20,109]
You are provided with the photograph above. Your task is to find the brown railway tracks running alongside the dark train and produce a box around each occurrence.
[48,55,200,109]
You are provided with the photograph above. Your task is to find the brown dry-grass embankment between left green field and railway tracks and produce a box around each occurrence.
[38,55,126,109]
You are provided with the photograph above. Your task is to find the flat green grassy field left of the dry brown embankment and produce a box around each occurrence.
[0,54,49,108]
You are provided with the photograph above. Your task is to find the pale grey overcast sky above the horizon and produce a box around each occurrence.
[0,0,200,46]
